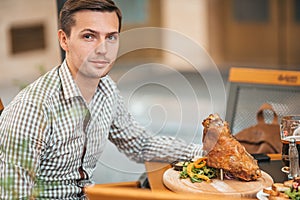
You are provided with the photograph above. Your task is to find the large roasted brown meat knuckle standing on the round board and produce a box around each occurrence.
[202,114,261,181]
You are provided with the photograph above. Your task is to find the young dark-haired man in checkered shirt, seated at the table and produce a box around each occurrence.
[0,0,201,199]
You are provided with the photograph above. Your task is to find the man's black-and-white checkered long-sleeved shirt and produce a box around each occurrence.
[0,62,201,199]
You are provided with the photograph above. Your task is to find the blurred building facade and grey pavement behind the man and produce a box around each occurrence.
[0,0,300,183]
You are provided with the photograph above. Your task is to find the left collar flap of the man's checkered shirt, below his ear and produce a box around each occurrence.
[59,60,82,99]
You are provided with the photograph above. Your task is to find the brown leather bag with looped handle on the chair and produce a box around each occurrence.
[235,103,282,154]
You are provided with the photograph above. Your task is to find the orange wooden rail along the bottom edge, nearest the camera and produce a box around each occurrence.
[85,185,234,200]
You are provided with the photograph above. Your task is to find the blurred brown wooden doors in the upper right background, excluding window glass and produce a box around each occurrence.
[209,0,300,69]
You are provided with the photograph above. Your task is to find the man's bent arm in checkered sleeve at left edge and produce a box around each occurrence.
[0,100,46,199]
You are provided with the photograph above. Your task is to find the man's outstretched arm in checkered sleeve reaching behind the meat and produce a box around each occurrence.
[109,90,202,162]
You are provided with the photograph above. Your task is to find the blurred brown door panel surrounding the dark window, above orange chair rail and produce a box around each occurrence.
[224,0,279,65]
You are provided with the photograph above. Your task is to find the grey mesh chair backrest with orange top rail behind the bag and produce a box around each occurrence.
[225,68,300,134]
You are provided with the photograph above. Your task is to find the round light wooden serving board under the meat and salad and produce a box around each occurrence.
[163,168,273,198]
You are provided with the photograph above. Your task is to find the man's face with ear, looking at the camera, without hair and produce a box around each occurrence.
[59,10,119,79]
